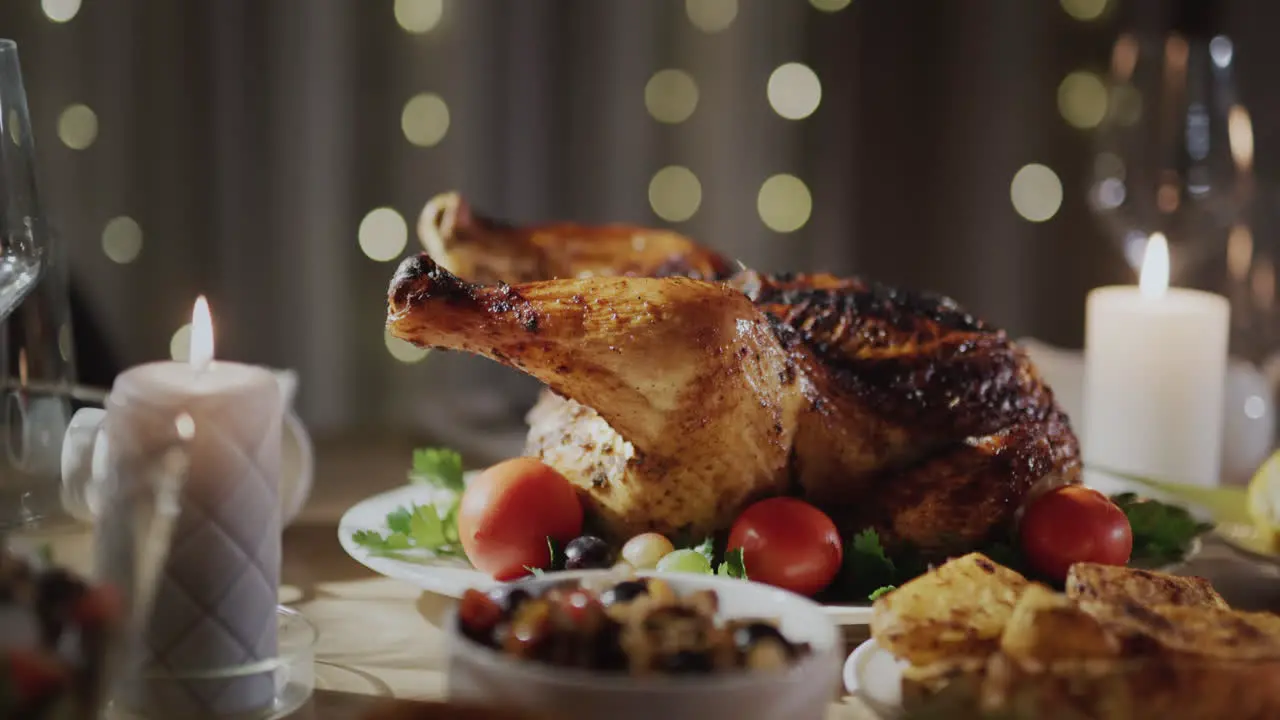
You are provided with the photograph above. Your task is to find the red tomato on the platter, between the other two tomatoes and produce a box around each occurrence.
[727,497,844,596]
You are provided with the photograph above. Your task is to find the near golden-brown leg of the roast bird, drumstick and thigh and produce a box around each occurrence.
[388,255,803,537]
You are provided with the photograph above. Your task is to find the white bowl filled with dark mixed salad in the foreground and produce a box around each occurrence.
[447,570,844,720]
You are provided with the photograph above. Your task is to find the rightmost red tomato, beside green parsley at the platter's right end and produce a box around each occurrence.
[1019,486,1133,582]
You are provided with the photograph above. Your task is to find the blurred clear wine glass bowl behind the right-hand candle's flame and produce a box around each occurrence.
[1089,17,1253,280]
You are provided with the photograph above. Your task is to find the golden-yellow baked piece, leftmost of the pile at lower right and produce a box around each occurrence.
[870,552,1030,665]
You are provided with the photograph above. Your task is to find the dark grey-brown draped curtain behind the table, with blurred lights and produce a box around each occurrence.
[0,0,1280,448]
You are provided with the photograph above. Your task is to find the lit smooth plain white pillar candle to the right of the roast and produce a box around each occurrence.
[1082,233,1230,486]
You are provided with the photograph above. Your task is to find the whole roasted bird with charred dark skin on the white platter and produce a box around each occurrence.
[388,193,1079,553]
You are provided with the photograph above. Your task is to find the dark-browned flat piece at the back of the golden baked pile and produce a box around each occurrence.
[1066,562,1226,609]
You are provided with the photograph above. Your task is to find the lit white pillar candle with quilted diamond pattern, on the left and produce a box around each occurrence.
[97,299,283,717]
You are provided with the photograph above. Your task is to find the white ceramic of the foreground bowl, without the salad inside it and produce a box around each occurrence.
[445,570,844,720]
